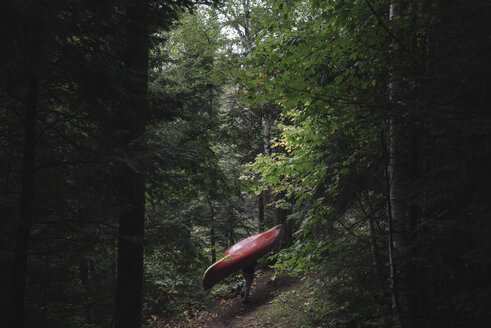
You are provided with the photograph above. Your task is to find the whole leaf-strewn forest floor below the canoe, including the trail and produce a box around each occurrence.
[157,268,303,328]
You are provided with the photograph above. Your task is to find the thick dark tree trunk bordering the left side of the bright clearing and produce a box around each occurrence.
[115,0,149,328]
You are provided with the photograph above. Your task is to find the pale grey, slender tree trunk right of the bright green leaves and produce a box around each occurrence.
[389,1,416,328]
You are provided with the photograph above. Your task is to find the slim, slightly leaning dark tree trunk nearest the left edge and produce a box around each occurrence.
[11,72,39,328]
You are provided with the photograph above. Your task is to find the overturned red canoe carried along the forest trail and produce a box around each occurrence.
[203,224,284,290]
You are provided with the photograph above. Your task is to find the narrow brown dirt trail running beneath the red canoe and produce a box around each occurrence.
[198,270,301,328]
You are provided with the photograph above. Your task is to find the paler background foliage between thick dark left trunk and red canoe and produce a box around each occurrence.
[140,8,262,318]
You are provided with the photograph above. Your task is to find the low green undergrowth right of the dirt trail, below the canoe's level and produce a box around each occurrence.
[272,205,390,327]
